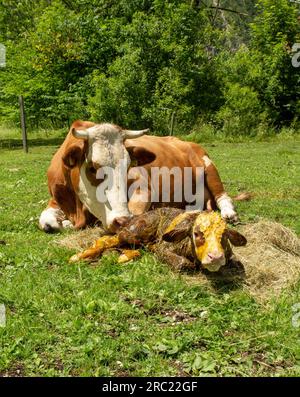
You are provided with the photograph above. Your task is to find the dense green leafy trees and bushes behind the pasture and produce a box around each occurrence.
[0,0,300,136]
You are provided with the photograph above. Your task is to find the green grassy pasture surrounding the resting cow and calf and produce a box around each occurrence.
[0,127,300,376]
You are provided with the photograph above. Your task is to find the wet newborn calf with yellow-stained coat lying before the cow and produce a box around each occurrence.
[70,208,247,272]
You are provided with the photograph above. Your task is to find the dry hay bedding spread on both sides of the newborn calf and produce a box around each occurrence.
[57,220,300,301]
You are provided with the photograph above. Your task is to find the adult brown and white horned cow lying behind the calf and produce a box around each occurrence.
[39,121,237,232]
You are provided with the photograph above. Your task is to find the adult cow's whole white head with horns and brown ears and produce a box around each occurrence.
[63,124,155,231]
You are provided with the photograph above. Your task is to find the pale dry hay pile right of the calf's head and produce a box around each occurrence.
[234,220,300,300]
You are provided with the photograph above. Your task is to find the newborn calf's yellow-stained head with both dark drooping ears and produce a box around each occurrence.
[163,211,247,272]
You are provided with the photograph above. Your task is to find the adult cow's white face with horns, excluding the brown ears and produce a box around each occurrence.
[72,124,148,228]
